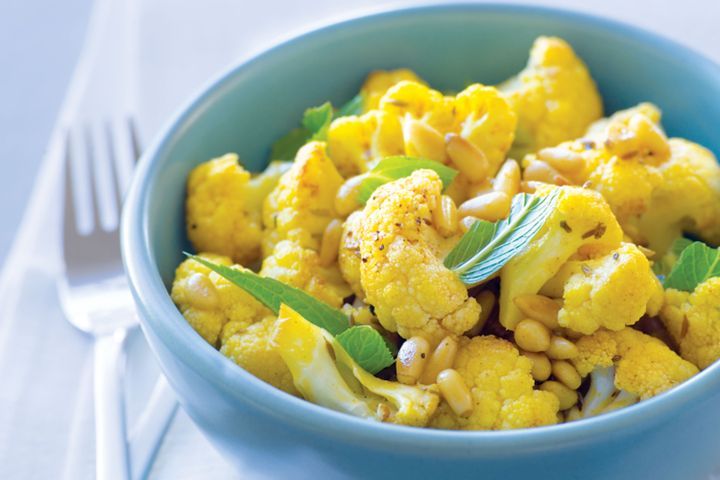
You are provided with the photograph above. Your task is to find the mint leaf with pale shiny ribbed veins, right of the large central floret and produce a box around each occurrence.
[445,190,558,287]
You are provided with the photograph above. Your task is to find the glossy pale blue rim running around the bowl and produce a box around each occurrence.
[121,2,720,450]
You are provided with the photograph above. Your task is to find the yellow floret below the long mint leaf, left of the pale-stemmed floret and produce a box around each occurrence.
[220,316,299,395]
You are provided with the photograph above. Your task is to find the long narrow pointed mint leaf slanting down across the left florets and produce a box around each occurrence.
[185,253,350,336]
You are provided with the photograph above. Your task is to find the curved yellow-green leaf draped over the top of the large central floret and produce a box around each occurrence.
[357,156,458,205]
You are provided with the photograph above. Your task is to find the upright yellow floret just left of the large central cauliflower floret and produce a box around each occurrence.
[263,142,343,256]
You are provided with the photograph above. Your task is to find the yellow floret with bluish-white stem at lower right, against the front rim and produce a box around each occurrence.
[572,327,698,417]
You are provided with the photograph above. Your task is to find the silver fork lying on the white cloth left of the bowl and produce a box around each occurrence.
[58,121,139,480]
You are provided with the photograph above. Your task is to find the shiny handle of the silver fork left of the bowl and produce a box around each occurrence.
[95,329,130,480]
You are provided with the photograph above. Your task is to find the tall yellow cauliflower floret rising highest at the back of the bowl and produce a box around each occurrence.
[498,37,602,156]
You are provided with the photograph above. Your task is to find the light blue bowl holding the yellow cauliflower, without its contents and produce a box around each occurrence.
[122,5,720,480]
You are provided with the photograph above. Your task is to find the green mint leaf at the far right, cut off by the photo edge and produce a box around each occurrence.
[663,242,720,292]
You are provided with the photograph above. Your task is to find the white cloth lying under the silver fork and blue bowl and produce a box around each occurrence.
[0,0,720,480]
